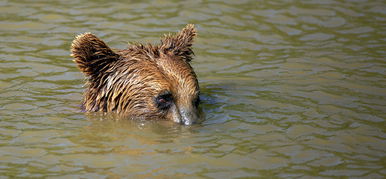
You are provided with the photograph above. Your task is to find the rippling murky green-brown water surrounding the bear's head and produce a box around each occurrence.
[0,0,386,178]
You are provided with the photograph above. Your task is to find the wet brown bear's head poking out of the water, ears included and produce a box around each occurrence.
[71,24,200,125]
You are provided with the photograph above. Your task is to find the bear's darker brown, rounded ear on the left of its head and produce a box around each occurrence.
[71,32,119,77]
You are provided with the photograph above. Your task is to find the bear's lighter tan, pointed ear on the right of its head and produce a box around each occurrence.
[160,24,196,62]
